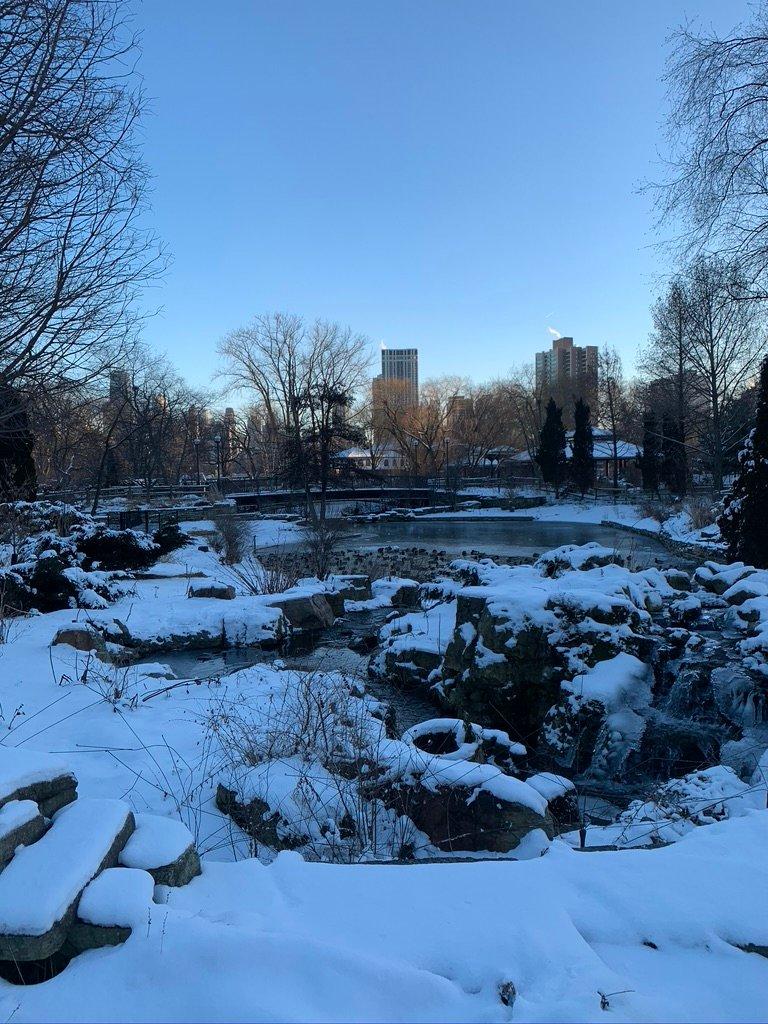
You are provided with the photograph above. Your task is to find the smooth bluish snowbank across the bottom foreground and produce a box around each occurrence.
[6,812,768,1022]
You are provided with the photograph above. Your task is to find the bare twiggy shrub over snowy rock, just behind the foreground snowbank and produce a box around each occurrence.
[207,672,415,863]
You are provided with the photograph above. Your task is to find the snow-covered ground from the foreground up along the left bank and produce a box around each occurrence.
[0,506,768,1022]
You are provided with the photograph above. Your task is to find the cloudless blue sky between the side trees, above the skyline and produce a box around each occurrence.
[137,0,746,384]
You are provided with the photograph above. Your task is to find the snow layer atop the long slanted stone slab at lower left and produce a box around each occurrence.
[0,800,128,935]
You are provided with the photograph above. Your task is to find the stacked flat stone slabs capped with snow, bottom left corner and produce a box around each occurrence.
[0,748,200,964]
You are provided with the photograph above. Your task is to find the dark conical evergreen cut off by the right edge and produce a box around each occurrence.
[718,357,768,568]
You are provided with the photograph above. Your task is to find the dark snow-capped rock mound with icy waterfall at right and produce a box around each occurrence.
[369,544,768,785]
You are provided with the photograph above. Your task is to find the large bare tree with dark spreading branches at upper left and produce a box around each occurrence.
[0,0,162,411]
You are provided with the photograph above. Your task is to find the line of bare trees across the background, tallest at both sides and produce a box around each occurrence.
[0,0,768,520]
